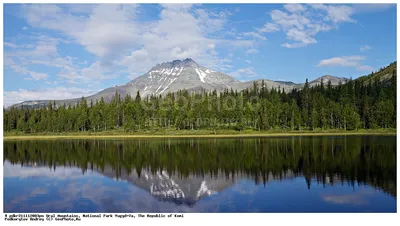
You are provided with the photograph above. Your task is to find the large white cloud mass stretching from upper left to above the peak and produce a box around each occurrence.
[21,4,253,73]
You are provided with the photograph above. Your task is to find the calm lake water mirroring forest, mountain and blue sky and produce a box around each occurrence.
[3,136,396,213]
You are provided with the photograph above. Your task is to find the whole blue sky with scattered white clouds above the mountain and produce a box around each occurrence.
[3,4,397,106]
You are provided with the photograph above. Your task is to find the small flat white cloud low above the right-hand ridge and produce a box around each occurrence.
[317,56,373,71]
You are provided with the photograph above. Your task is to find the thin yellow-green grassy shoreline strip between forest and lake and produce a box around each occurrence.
[3,129,397,140]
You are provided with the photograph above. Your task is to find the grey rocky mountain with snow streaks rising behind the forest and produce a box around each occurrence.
[13,58,347,108]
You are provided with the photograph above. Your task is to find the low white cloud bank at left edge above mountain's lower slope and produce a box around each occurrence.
[4,86,98,106]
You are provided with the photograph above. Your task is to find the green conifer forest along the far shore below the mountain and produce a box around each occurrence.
[3,70,396,133]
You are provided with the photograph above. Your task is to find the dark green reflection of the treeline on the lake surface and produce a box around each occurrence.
[4,136,396,197]
